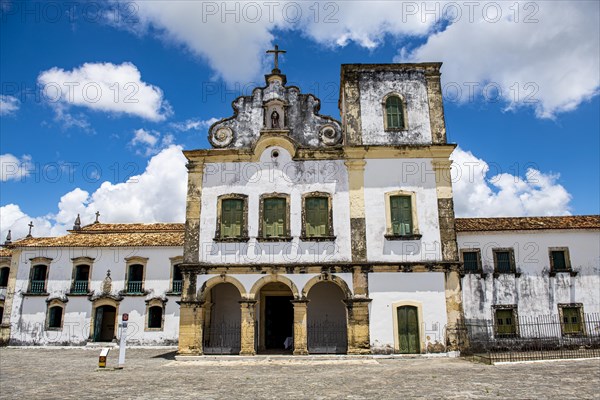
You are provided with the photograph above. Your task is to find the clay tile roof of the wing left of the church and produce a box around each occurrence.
[11,223,184,247]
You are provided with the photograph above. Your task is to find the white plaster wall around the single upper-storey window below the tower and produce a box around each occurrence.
[365,159,442,262]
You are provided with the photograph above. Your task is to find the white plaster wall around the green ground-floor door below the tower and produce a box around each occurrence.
[369,272,447,352]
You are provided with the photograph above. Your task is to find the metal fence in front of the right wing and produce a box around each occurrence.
[457,313,600,362]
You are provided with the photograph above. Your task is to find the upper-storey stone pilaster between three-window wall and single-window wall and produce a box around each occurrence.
[345,159,367,261]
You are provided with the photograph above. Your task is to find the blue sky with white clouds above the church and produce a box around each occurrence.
[0,1,600,237]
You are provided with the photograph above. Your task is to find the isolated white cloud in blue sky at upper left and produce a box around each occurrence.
[38,63,172,125]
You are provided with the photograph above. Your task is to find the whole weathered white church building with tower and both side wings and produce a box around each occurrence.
[0,63,600,356]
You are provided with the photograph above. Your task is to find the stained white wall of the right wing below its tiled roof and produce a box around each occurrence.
[458,230,600,319]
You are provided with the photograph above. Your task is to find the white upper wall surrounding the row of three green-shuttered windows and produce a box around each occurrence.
[200,146,351,264]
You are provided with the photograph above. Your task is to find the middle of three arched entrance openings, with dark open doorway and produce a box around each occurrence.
[258,282,294,353]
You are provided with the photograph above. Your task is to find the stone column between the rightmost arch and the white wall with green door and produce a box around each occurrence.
[344,299,371,354]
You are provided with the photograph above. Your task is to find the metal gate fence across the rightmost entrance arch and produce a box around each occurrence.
[307,318,348,354]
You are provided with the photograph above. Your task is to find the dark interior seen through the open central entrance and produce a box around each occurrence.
[265,296,294,349]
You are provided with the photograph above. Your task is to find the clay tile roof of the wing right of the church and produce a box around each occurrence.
[456,215,600,232]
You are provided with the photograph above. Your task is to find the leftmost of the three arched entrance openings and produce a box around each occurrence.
[203,283,242,354]
